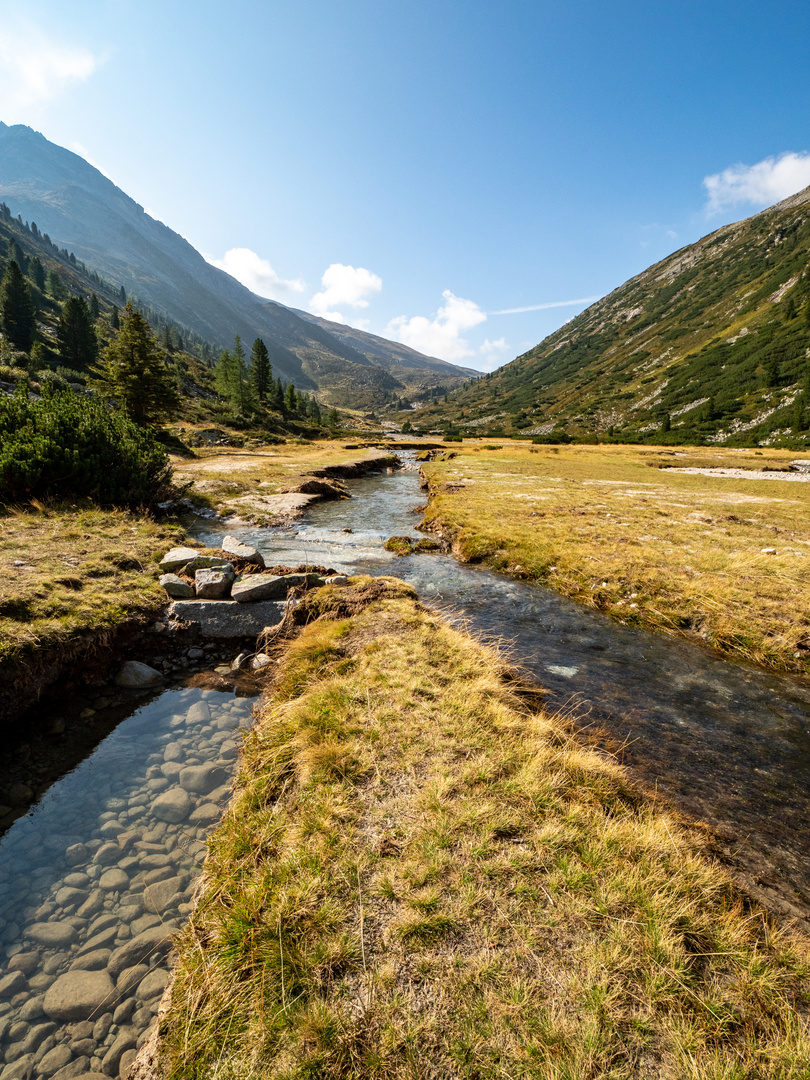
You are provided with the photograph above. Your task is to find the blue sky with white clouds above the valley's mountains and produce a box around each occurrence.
[0,0,810,369]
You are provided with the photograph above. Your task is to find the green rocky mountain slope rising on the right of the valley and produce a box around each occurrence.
[421,188,810,444]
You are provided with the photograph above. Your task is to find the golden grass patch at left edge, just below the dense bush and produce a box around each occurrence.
[0,507,183,660]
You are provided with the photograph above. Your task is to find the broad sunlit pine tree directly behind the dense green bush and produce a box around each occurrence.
[94,303,180,427]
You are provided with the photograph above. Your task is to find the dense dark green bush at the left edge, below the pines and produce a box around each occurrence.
[0,387,172,508]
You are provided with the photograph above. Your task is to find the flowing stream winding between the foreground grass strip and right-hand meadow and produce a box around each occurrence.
[197,460,810,917]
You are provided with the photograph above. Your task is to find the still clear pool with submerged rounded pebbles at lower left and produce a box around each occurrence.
[0,690,252,1080]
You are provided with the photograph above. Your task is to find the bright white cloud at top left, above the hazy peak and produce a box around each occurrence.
[0,27,105,115]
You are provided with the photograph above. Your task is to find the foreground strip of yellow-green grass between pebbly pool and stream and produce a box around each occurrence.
[162,585,810,1080]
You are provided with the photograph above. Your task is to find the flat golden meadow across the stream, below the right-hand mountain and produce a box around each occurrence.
[424,444,810,673]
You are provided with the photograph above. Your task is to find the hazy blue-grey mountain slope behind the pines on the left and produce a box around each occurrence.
[0,124,473,407]
